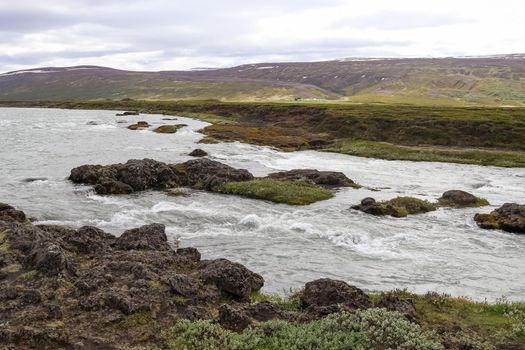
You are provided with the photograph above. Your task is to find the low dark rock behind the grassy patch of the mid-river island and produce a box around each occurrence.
[267,169,359,188]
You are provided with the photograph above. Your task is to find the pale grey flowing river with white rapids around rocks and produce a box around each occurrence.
[0,108,525,301]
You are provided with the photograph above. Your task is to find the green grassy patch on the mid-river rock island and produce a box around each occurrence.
[213,179,333,205]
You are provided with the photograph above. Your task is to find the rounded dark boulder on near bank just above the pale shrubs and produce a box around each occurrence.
[301,278,372,310]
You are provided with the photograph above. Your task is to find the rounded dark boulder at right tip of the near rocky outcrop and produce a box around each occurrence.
[202,259,264,299]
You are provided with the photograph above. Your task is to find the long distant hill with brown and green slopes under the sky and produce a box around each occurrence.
[0,55,525,106]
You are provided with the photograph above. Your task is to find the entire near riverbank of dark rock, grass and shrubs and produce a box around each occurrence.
[0,204,525,350]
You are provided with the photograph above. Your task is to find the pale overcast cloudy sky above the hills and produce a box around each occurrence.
[0,0,525,72]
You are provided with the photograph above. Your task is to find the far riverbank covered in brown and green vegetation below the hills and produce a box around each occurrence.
[4,100,525,167]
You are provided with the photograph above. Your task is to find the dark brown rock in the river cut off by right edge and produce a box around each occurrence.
[474,203,525,233]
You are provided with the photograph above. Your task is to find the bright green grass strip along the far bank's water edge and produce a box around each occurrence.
[324,139,525,167]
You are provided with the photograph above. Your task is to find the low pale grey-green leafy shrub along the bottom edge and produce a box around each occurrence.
[159,309,443,350]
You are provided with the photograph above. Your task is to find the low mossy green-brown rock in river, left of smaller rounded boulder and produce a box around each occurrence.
[352,197,437,218]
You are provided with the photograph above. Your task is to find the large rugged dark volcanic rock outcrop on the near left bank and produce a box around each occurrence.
[0,204,275,349]
